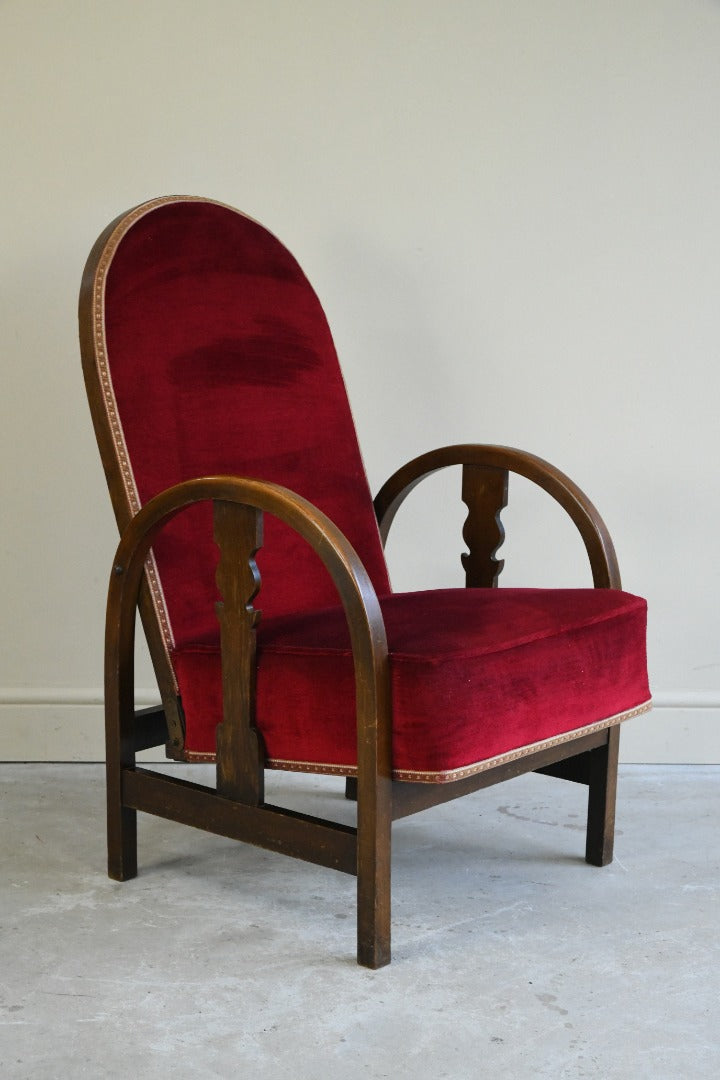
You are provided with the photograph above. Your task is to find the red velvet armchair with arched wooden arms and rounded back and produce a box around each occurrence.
[80,198,650,968]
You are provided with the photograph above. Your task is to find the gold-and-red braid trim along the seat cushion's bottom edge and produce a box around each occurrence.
[181,700,652,784]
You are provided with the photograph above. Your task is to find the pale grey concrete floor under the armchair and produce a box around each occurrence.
[0,765,720,1080]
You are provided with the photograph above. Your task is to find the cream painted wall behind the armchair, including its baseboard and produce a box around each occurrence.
[0,0,720,761]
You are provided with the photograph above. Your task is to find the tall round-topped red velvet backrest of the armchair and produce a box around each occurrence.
[98,199,390,649]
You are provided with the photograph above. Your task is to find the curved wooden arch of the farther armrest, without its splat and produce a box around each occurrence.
[375,443,621,589]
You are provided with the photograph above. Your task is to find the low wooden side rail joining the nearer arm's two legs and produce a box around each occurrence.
[122,769,356,874]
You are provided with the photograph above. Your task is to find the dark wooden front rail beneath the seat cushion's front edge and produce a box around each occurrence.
[393,731,607,821]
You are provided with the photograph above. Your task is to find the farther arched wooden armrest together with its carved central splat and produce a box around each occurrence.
[375,443,621,589]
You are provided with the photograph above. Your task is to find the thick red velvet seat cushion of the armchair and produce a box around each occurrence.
[174,589,650,781]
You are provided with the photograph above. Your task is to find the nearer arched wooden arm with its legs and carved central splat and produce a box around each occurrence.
[105,476,392,968]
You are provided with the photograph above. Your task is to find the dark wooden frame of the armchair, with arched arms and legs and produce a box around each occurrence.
[98,442,621,968]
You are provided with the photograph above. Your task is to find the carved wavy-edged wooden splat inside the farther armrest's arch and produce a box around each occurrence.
[461,464,507,589]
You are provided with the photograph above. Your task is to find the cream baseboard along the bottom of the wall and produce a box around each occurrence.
[0,687,720,765]
